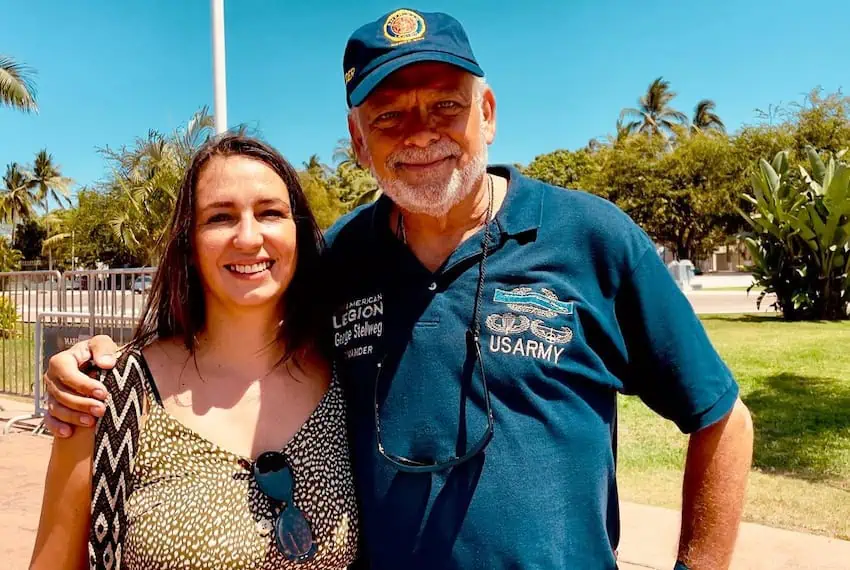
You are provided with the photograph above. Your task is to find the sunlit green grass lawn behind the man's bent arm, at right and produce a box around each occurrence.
[619,315,850,539]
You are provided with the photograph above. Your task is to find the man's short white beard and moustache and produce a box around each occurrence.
[370,141,488,218]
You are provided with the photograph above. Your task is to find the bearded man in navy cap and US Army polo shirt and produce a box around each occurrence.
[45,9,752,570]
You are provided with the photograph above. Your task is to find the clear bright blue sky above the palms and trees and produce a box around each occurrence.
[0,0,850,201]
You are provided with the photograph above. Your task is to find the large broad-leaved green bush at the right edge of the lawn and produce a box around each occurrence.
[739,147,850,320]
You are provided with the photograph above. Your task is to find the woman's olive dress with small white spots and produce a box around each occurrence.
[94,352,359,570]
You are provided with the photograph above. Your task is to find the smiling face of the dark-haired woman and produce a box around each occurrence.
[193,156,297,310]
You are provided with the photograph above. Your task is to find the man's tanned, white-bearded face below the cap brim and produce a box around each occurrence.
[349,63,495,216]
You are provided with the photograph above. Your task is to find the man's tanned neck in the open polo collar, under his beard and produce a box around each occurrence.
[390,173,508,271]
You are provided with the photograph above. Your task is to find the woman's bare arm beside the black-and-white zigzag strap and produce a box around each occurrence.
[30,429,95,570]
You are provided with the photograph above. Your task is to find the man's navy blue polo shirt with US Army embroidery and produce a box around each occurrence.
[327,162,738,570]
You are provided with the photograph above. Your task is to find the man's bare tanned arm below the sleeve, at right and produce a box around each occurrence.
[678,399,753,570]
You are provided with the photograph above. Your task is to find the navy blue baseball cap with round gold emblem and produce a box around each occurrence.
[342,8,484,107]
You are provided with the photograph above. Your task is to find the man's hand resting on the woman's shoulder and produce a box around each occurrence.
[44,335,118,437]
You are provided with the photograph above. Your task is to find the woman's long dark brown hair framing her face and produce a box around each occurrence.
[131,134,325,361]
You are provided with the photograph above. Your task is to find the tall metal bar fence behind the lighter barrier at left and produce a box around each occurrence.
[0,267,156,400]
